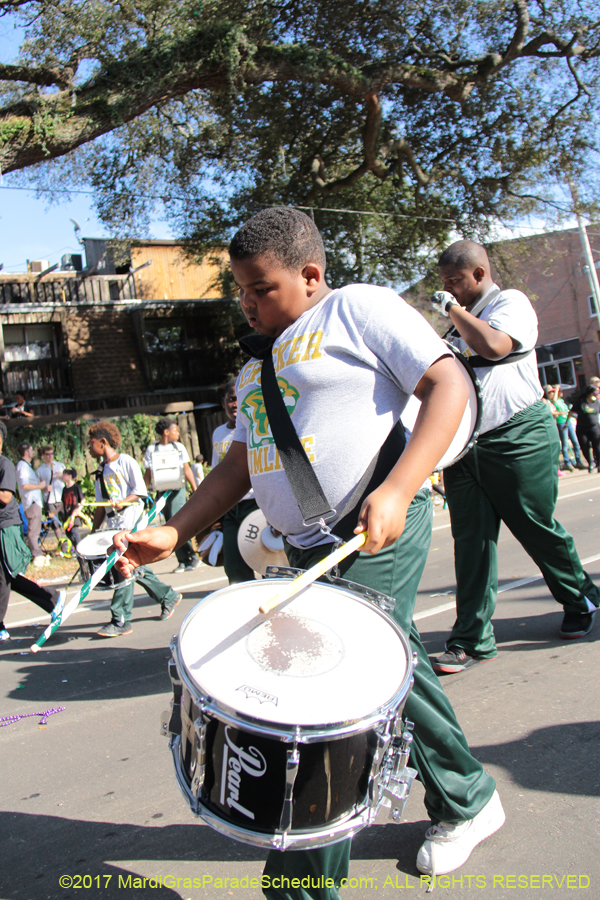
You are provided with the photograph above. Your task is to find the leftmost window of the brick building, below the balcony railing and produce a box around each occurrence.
[2,322,71,397]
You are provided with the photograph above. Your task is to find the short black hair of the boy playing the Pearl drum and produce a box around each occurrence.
[229,206,327,272]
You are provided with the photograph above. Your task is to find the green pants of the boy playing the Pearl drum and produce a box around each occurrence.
[263,490,495,900]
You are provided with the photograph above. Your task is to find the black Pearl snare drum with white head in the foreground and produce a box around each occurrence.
[163,569,416,850]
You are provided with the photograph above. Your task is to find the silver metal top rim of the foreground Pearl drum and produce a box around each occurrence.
[176,578,414,744]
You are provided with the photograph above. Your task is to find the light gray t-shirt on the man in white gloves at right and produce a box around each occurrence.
[448,285,543,434]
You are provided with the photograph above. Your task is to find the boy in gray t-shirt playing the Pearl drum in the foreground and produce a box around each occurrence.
[115,208,504,900]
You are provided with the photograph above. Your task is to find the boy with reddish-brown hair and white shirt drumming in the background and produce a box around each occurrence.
[88,421,182,637]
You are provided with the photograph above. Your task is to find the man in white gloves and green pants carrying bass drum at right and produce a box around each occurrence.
[433,241,600,673]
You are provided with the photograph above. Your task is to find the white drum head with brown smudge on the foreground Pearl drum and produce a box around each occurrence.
[179,578,408,726]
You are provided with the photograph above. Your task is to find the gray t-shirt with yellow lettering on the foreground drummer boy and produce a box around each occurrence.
[234,284,449,548]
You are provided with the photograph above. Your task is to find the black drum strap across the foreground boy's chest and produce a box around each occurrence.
[240,335,406,540]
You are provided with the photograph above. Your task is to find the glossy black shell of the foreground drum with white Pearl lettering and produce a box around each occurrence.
[179,691,377,834]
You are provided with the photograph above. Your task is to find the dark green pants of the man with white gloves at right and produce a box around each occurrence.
[444,401,600,659]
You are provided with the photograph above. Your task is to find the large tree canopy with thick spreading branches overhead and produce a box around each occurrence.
[0,0,600,284]
